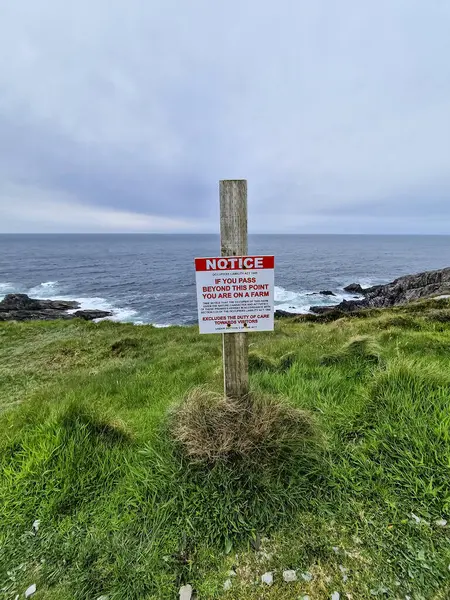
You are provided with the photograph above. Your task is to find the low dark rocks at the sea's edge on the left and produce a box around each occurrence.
[0,294,112,321]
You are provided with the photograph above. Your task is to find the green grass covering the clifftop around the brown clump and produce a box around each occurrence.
[0,299,450,600]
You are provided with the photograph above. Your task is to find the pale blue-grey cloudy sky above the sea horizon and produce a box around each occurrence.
[0,0,450,234]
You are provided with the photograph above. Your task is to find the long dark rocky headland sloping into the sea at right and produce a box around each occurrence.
[311,267,450,314]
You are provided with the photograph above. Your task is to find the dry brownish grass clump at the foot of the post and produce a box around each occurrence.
[171,388,319,464]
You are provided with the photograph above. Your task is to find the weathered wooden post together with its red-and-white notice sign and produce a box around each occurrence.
[195,180,275,398]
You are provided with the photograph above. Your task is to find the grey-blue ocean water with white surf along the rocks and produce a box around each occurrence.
[0,234,450,326]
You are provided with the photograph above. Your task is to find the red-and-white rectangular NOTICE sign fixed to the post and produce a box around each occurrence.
[195,256,275,333]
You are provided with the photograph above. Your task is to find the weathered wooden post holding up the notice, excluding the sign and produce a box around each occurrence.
[220,179,249,399]
